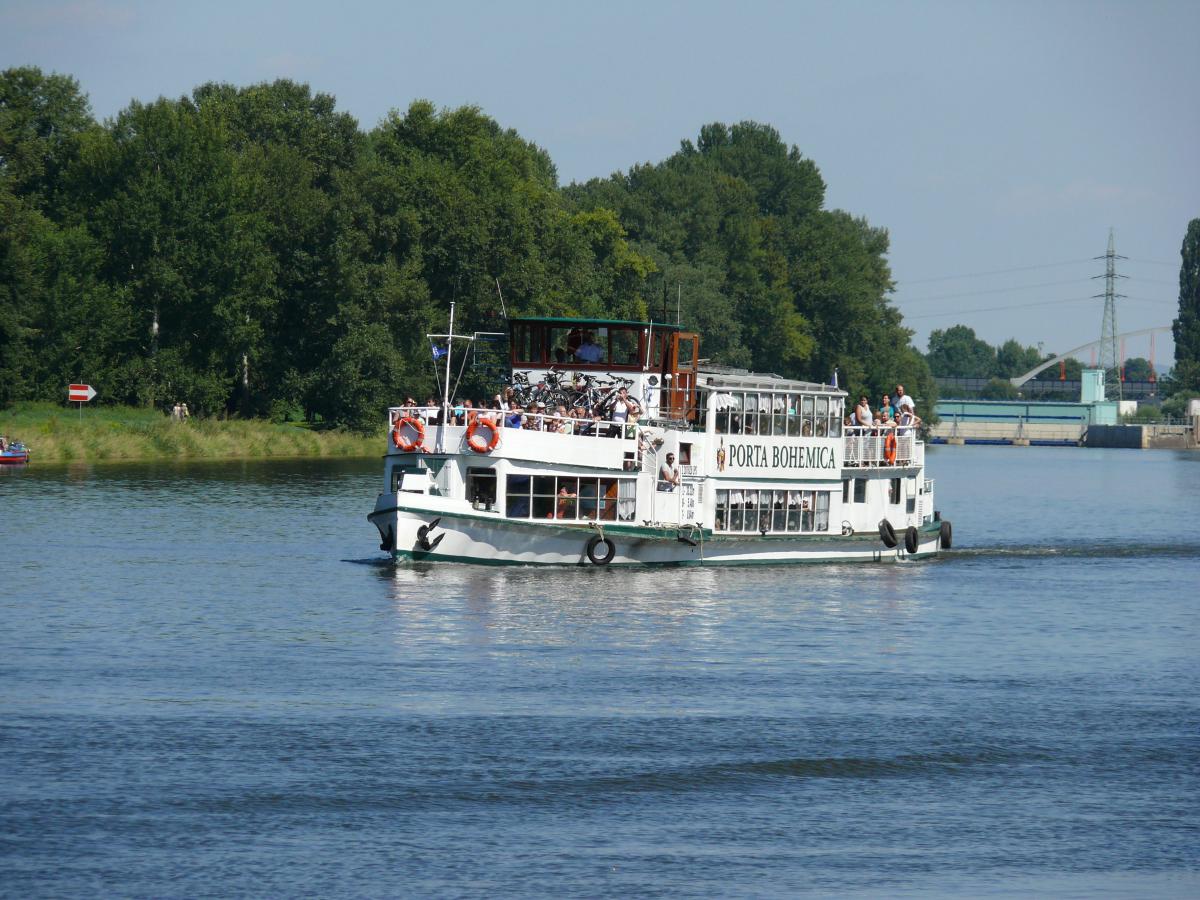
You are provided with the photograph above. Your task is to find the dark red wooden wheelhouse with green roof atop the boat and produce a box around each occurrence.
[509,317,680,372]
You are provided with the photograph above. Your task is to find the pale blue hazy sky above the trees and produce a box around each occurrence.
[0,0,1200,368]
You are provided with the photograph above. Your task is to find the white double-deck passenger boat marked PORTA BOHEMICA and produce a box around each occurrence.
[367,310,952,566]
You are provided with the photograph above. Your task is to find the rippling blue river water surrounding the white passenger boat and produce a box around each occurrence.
[0,446,1200,898]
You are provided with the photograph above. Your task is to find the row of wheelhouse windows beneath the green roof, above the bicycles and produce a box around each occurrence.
[512,324,668,370]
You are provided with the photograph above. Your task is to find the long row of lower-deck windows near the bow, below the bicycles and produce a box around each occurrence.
[504,475,637,522]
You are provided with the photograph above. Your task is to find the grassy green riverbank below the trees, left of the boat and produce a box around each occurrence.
[0,403,383,464]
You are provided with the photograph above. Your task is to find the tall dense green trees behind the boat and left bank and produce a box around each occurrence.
[0,67,936,427]
